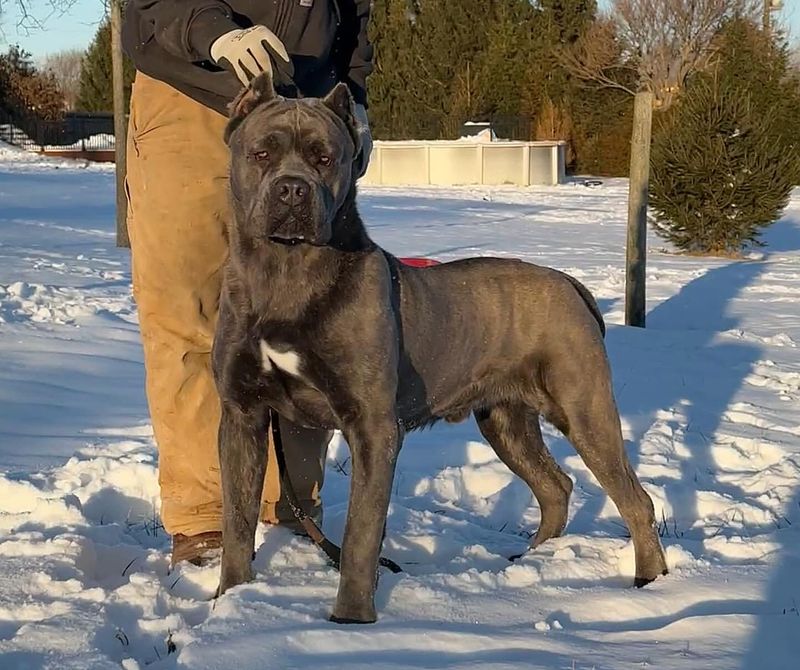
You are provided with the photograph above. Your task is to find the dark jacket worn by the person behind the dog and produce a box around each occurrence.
[122,0,372,114]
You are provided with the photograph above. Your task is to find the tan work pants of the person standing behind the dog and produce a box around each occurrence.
[127,73,330,535]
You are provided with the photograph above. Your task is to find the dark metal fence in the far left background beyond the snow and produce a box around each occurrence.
[0,110,114,151]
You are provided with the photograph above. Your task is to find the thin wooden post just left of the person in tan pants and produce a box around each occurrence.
[110,0,131,247]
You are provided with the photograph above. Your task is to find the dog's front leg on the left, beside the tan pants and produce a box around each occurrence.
[218,403,267,595]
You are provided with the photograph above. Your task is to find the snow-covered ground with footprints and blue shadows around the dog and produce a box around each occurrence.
[0,147,800,670]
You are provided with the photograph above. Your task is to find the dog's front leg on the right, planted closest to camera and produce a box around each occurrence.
[331,410,402,623]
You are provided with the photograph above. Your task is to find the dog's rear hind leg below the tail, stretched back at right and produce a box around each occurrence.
[549,356,667,586]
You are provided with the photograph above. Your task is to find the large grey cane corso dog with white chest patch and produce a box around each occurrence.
[213,75,667,623]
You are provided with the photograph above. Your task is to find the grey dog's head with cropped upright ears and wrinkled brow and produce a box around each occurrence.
[225,74,359,246]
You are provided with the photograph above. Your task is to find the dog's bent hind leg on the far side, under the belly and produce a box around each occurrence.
[475,403,572,547]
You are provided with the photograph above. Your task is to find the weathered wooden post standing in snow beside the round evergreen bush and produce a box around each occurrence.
[625,91,653,328]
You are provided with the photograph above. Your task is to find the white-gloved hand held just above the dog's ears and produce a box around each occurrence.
[211,26,294,86]
